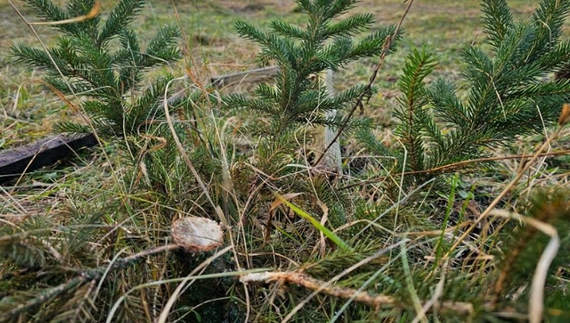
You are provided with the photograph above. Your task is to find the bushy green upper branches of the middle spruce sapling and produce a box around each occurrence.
[224,0,396,137]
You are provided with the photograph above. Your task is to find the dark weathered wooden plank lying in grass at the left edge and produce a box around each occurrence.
[0,134,97,184]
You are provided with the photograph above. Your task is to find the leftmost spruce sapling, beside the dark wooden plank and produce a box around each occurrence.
[12,0,200,213]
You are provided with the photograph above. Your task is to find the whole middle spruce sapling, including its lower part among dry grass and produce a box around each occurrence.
[216,0,399,246]
